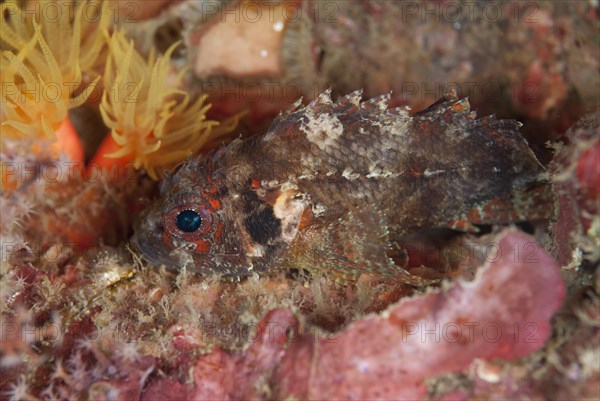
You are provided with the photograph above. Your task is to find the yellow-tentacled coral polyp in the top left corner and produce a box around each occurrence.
[0,0,110,140]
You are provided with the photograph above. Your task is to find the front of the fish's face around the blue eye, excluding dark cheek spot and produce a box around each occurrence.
[132,150,246,275]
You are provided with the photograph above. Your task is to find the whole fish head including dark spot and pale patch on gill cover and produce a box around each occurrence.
[132,145,306,277]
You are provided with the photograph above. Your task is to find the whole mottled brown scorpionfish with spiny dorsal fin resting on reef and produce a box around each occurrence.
[133,91,544,285]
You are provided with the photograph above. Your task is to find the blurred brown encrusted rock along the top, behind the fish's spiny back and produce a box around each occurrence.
[125,0,600,145]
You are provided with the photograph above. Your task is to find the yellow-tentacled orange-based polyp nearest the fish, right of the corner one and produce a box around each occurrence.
[100,31,237,179]
